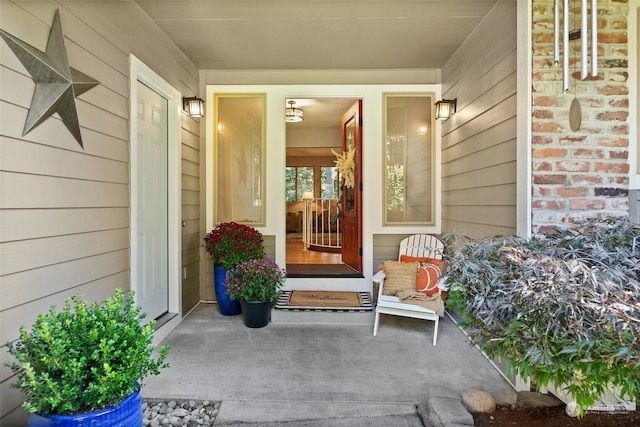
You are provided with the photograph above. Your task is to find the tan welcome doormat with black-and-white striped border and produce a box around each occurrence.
[276,291,373,311]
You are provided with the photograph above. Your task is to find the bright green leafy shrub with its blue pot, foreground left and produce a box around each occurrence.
[6,289,169,426]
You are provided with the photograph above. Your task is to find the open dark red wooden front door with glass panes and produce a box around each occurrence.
[342,100,362,272]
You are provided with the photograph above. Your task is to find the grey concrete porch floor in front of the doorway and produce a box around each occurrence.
[142,304,516,427]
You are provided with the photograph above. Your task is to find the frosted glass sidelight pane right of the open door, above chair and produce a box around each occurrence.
[384,93,434,225]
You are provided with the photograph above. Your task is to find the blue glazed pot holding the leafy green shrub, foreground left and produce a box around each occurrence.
[27,389,142,427]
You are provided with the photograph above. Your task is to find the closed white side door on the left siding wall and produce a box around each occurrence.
[134,82,169,321]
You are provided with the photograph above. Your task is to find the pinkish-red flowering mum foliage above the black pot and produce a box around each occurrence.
[225,258,287,301]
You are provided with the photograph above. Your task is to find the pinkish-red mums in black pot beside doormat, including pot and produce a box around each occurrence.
[225,258,287,328]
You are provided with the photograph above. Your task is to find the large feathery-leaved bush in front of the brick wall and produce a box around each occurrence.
[445,218,640,415]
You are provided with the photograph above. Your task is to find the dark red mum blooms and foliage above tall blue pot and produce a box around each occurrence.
[204,222,264,269]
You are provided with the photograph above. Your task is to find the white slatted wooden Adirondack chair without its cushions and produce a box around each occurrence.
[373,234,444,346]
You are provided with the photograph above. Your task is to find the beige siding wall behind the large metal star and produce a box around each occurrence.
[0,0,202,425]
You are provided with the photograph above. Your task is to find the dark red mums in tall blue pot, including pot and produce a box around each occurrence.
[204,222,265,316]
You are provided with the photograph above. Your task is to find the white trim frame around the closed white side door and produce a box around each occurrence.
[129,55,182,332]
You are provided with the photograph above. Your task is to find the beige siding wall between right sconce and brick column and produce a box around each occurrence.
[442,1,517,237]
